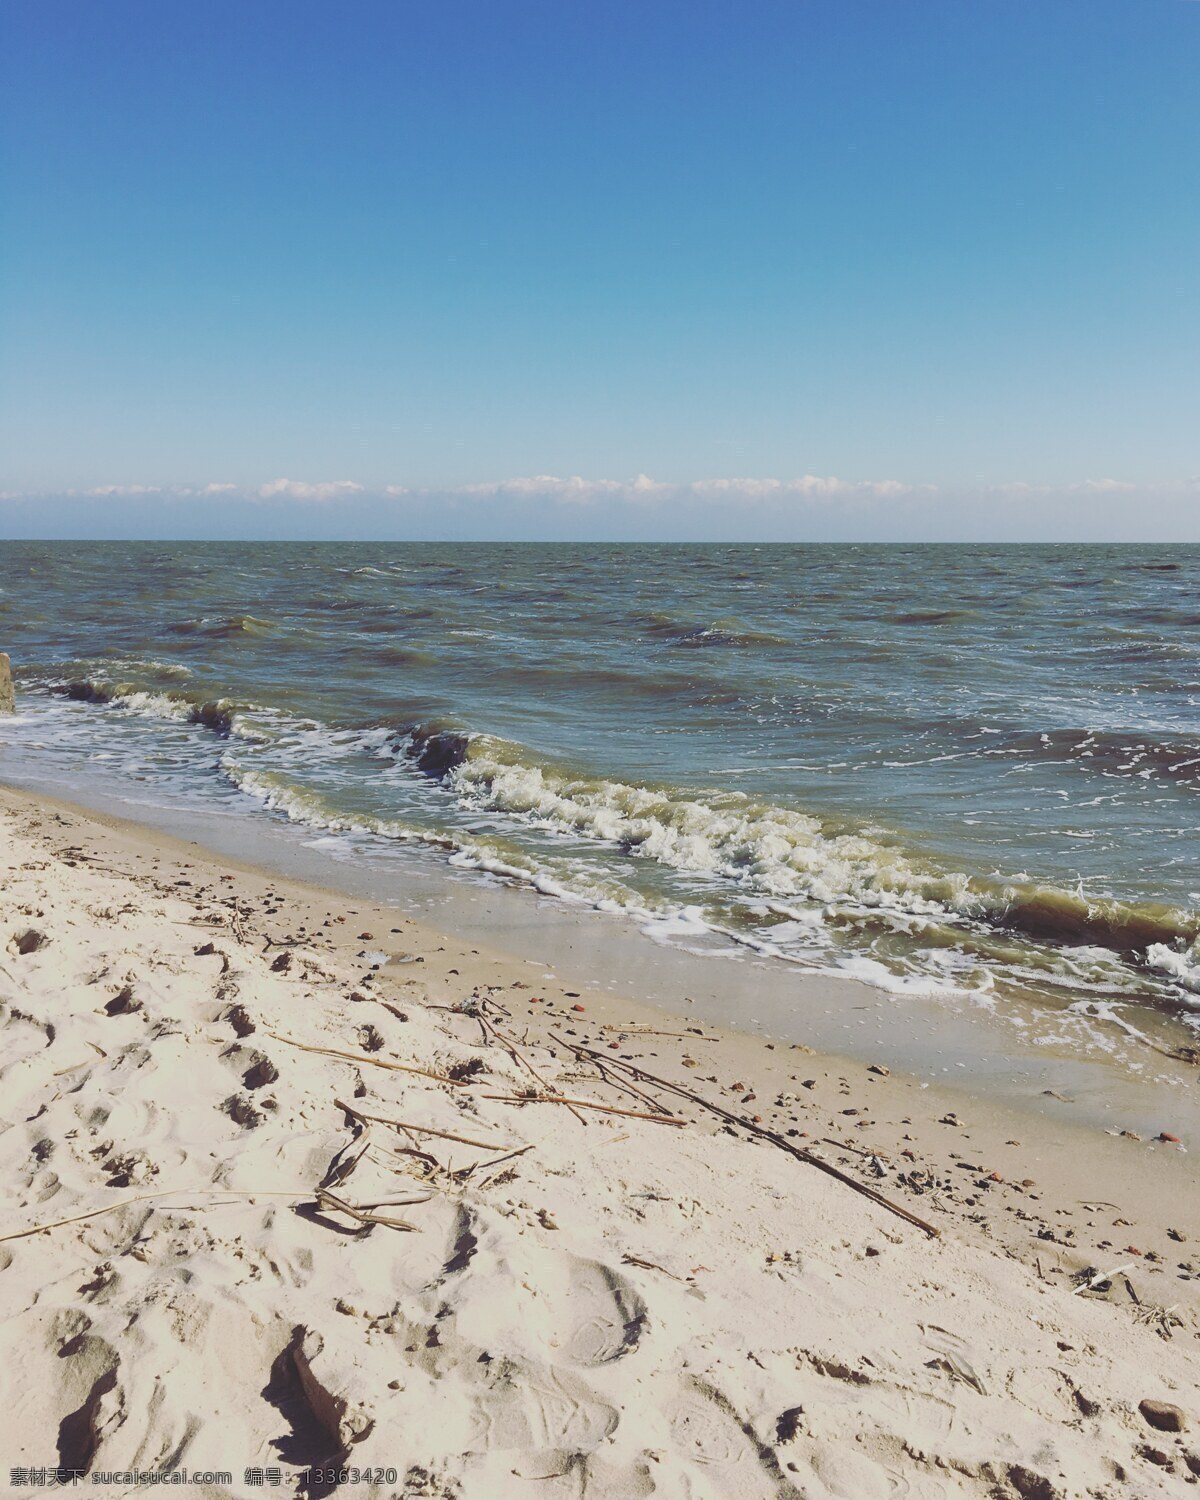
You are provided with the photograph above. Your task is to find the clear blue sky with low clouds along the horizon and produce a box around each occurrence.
[0,0,1200,540]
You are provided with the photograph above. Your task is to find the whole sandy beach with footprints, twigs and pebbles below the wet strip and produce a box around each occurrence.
[0,792,1200,1500]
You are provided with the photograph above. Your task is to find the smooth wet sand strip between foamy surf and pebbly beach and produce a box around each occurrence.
[0,762,1200,1142]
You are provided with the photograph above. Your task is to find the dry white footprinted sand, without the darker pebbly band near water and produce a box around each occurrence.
[0,797,1200,1500]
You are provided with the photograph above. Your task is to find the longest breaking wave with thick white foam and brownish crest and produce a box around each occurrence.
[393,728,1200,989]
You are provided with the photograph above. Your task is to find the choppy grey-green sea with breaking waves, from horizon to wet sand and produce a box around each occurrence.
[0,543,1200,1044]
